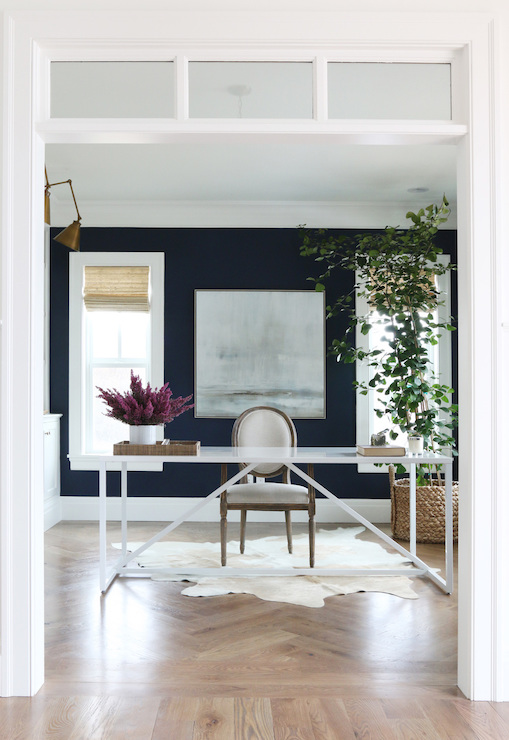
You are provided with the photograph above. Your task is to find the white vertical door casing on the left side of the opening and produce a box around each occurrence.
[0,17,44,696]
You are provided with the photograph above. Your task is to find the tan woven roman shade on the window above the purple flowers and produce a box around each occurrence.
[83,265,150,312]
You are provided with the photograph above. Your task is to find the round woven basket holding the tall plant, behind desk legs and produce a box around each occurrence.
[389,465,458,543]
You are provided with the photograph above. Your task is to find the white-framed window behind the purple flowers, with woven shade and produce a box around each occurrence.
[69,252,164,469]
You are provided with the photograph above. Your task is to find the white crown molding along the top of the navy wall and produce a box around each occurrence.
[51,198,456,229]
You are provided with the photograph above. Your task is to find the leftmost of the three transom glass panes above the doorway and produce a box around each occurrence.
[51,62,175,118]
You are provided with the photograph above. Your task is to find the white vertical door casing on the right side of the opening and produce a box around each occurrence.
[458,22,502,701]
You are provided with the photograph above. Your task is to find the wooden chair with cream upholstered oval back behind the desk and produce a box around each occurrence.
[220,406,315,568]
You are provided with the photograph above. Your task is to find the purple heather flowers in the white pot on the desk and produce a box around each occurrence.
[97,370,194,426]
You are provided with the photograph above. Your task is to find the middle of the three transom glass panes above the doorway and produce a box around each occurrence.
[189,62,313,118]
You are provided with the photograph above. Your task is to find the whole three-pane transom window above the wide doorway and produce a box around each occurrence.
[50,59,452,121]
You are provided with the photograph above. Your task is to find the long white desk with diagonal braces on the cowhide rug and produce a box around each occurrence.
[71,447,453,594]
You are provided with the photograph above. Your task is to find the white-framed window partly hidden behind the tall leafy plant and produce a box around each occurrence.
[356,255,452,473]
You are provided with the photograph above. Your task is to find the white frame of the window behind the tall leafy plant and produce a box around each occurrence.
[355,254,452,473]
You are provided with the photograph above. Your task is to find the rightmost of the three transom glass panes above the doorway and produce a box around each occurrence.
[327,62,451,120]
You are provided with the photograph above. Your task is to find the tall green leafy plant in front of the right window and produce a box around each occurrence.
[300,198,457,485]
